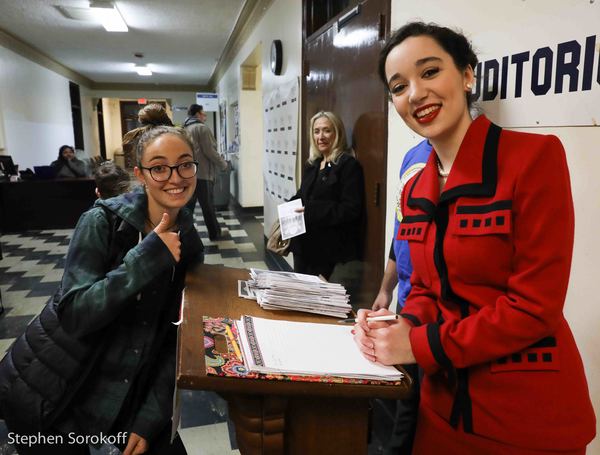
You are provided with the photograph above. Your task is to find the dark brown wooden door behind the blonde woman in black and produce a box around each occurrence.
[302,0,390,307]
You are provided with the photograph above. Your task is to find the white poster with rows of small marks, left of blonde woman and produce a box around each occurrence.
[263,79,299,205]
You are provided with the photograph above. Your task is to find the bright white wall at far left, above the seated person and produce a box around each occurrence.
[0,46,90,169]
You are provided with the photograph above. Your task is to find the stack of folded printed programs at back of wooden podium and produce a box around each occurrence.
[238,269,352,318]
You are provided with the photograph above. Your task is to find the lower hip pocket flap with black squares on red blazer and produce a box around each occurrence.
[491,337,560,373]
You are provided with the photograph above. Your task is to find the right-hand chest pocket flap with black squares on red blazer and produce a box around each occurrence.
[452,201,512,235]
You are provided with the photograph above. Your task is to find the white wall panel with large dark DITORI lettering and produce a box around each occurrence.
[463,0,600,127]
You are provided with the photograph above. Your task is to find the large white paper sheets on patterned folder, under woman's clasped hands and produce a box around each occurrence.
[236,316,404,381]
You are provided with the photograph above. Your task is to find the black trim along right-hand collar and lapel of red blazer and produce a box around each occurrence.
[440,123,502,202]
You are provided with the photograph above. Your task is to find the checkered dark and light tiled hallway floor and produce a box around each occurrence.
[0,207,390,455]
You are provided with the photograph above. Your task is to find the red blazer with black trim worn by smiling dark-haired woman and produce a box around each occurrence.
[398,116,595,450]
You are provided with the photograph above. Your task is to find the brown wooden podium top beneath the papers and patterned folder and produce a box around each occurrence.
[177,264,412,399]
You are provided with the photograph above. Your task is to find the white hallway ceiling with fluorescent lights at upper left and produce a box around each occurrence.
[0,0,246,86]
